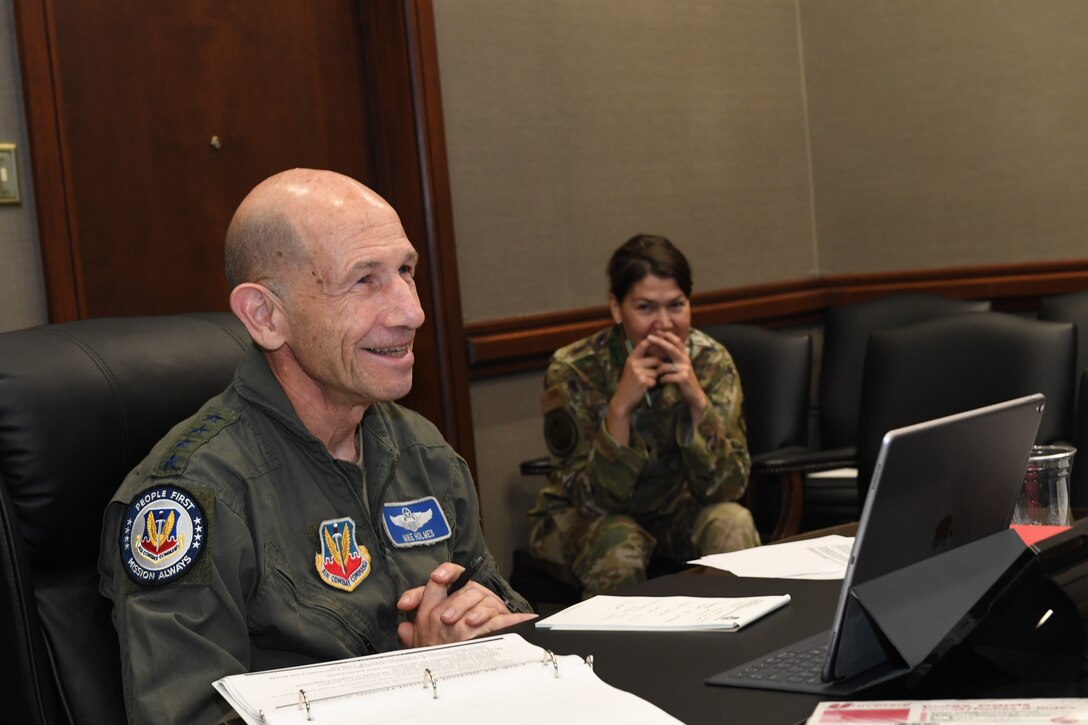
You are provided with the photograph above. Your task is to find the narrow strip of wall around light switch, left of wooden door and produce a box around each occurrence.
[0,0,47,331]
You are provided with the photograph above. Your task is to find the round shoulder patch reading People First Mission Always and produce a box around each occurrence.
[120,486,208,587]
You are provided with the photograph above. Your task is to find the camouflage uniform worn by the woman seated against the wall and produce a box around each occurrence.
[529,325,759,595]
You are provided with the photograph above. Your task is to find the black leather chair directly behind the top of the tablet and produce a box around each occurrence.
[857,312,1075,501]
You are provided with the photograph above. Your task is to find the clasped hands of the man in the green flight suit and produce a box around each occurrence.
[397,563,536,647]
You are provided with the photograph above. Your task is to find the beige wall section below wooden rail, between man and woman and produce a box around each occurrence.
[472,371,547,575]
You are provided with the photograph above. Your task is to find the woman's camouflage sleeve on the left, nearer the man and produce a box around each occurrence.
[542,360,648,516]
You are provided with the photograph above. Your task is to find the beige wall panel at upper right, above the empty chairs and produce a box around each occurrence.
[801,0,1088,274]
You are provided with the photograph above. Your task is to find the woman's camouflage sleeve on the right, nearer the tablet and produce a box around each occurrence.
[677,351,752,502]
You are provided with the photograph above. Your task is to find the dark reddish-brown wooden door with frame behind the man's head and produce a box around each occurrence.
[14,0,473,462]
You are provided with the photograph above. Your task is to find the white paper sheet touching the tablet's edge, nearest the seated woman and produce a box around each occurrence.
[688,534,854,579]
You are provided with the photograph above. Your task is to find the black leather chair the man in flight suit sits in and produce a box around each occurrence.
[0,312,249,724]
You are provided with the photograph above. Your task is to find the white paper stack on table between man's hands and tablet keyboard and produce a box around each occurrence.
[536,594,790,631]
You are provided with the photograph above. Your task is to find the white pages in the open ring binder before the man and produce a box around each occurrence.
[214,635,680,725]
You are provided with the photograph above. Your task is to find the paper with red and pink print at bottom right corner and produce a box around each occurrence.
[806,698,1088,725]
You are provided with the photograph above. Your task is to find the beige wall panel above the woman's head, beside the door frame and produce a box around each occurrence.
[434,0,816,322]
